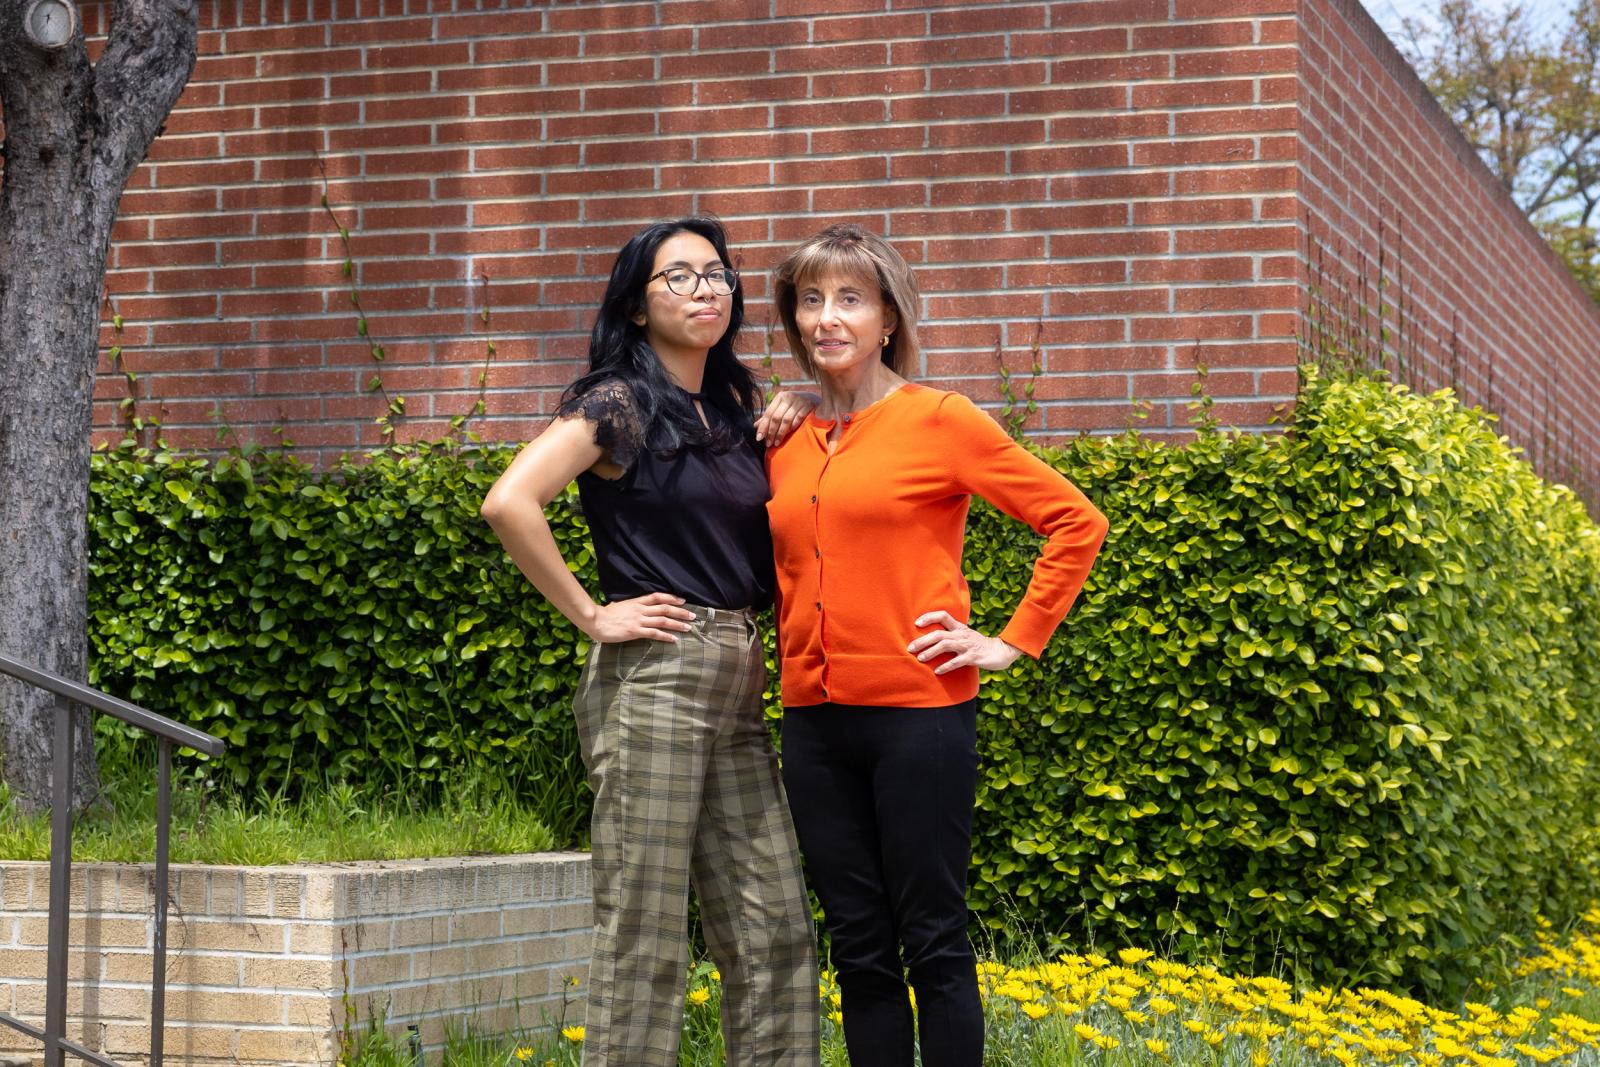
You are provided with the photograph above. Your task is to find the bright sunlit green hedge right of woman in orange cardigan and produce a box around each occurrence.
[968,373,1600,990]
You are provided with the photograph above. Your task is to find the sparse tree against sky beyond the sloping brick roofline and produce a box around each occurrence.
[1398,0,1600,301]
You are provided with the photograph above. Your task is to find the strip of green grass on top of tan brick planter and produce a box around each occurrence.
[0,773,557,865]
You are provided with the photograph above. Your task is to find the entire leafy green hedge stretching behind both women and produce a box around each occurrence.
[90,374,1600,989]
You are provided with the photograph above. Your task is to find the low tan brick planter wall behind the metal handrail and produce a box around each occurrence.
[0,853,590,1067]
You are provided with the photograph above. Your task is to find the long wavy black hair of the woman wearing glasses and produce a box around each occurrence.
[562,216,755,454]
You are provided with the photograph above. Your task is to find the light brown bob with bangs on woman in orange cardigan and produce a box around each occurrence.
[773,222,922,381]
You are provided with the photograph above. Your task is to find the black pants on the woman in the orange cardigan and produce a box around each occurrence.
[784,701,984,1067]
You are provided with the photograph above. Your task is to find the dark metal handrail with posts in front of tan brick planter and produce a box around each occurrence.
[0,656,226,1067]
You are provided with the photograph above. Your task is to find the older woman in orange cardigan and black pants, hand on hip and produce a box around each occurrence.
[766,226,1107,1067]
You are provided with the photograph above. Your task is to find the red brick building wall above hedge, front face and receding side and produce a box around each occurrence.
[53,0,1600,479]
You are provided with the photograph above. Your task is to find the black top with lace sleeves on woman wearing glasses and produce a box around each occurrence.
[557,381,774,608]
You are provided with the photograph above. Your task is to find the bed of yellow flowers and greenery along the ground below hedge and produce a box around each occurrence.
[341,909,1600,1067]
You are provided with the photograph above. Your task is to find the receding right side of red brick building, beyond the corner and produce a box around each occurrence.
[1299,0,1600,499]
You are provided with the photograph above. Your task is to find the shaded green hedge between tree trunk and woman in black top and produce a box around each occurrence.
[90,446,594,840]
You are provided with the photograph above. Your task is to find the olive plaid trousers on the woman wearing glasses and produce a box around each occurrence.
[573,605,821,1067]
